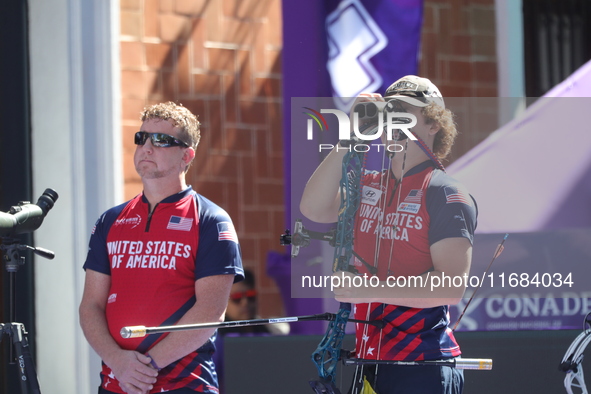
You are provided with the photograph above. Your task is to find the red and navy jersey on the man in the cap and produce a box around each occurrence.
[354,162,477,361]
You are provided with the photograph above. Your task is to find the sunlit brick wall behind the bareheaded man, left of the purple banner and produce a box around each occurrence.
[120,0,285,316]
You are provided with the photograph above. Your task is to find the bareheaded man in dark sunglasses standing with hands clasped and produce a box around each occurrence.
[80,102,243,394]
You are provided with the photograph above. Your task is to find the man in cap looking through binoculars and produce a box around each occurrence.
[300,76,477,394]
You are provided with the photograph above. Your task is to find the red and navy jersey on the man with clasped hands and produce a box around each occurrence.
[84,187,244,393]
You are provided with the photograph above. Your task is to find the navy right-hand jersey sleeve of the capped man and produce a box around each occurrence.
[427,179,478,245]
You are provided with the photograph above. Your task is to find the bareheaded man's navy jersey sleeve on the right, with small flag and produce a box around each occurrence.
[195,198,244,282]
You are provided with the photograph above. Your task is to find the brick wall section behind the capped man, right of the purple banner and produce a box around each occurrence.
[419,0,498,163]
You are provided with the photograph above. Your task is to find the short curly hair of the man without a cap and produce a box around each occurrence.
[140,101,201,149]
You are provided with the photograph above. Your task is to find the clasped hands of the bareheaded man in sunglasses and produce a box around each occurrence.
[109,350,158,394]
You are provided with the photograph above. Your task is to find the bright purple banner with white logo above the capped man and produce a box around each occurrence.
[326,0,422,109]
